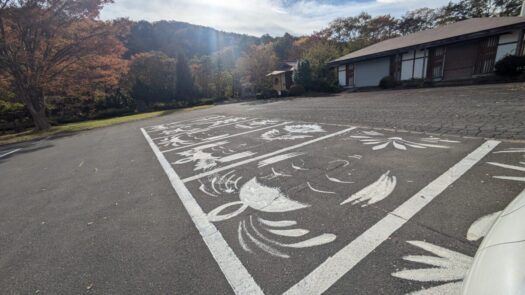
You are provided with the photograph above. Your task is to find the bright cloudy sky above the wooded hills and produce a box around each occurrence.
[101,0,448,36]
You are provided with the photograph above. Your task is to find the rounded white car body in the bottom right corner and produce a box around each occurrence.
[463,190,525,295]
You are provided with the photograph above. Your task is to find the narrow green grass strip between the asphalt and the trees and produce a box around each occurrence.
[0,105,210,145]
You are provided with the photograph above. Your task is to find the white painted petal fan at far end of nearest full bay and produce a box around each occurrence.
[350,131,458,151]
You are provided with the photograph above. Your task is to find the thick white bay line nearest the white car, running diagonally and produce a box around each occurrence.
[285,140,500,295]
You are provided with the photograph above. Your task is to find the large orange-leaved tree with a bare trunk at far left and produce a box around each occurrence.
[0,0,126,130]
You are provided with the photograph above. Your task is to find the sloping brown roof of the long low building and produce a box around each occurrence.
[330,16,525,63]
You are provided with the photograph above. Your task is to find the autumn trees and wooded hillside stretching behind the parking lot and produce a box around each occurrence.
[0,0,521,132]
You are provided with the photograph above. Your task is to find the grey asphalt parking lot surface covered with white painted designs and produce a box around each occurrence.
[0,84,525,294]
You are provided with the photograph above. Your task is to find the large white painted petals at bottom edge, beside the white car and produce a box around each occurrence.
[392,241,474,295]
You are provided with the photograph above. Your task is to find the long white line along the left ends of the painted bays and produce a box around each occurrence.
[141,128,264,294]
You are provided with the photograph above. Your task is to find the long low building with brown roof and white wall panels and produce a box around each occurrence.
[330,16,525,87]
